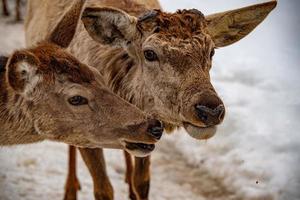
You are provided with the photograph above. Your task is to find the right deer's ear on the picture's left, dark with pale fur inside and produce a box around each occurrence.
[82,7,137,46]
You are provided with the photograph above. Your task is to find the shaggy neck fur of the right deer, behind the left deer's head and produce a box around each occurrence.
[70,36,177,132]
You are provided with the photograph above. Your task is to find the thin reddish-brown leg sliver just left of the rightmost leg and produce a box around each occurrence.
[124,151,138,200]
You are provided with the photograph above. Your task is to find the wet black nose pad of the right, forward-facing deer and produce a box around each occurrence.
[195,104,225,126]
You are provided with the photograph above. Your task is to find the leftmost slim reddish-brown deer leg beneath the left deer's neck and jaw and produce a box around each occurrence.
[64,146,80,200]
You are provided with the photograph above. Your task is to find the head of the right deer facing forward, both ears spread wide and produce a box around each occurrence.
[82,1,276,139]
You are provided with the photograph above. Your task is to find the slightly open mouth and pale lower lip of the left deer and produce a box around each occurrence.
[125,142,155,157]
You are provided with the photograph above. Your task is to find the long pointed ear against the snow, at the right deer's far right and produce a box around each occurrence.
[205,0,277,47]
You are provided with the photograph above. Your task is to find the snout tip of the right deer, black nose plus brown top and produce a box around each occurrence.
[195,95,225,126]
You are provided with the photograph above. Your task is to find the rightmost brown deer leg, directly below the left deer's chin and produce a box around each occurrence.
[133,156,150,200]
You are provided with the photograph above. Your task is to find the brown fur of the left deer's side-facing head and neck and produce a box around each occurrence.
[0,43,162,148]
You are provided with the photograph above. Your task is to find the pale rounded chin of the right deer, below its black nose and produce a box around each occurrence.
[183,122,217,140]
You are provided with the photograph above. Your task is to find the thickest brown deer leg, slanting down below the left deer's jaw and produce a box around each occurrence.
[79,148,114,200]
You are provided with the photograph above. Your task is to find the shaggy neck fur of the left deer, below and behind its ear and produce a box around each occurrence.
[0,57,42,146]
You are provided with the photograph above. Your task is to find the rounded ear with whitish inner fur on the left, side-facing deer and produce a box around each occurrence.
[6,51,40,96]
